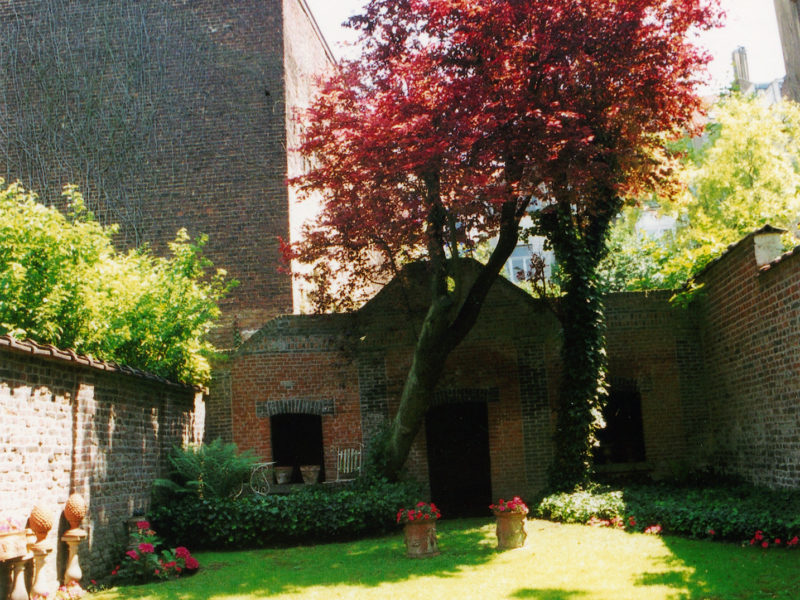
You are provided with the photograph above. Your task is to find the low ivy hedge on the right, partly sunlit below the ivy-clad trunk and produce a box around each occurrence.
[533,484,800,543]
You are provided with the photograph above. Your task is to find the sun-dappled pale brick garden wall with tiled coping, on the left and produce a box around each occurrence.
[0,336,204,598]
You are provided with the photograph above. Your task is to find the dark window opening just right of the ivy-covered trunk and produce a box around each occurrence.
[594,379,645,465]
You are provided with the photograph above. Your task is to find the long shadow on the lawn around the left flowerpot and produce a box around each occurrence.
[103,519,496,600]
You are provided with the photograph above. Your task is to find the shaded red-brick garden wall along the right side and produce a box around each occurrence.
[697,235,800,488]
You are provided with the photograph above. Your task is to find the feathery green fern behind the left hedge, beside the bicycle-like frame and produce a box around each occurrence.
[154,438,258,502]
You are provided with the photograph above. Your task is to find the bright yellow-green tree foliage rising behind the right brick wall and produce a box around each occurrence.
[600,94,800,291]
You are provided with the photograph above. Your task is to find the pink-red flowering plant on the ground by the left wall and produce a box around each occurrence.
[111,520,200,582]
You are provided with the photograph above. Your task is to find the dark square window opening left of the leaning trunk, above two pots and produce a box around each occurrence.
[270,414,325,483]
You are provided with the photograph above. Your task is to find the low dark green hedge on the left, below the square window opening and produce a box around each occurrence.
[149,479,420,549]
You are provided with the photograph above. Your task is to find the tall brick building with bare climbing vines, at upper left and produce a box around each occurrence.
[0,0,334,346]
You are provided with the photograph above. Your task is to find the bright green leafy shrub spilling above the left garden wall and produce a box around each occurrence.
[0,180,232,383]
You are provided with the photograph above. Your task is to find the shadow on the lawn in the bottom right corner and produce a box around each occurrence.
[636,536,800,600]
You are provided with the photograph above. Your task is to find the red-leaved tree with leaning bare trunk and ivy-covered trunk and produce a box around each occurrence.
[285,0,719,485]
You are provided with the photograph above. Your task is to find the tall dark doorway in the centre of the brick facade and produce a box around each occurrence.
[425,402,492,517]
